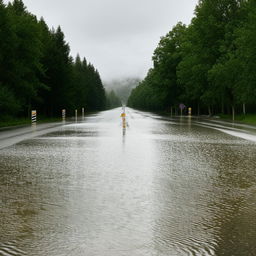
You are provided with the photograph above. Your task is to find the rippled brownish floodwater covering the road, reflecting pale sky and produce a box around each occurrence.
[0,109,256,256]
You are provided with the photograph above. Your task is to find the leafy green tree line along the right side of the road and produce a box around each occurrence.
[128,0,256,118]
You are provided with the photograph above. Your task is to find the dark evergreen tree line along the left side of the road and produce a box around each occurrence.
[0,0,106,118]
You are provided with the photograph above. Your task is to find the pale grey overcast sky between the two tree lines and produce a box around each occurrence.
[5,0,198,81]
